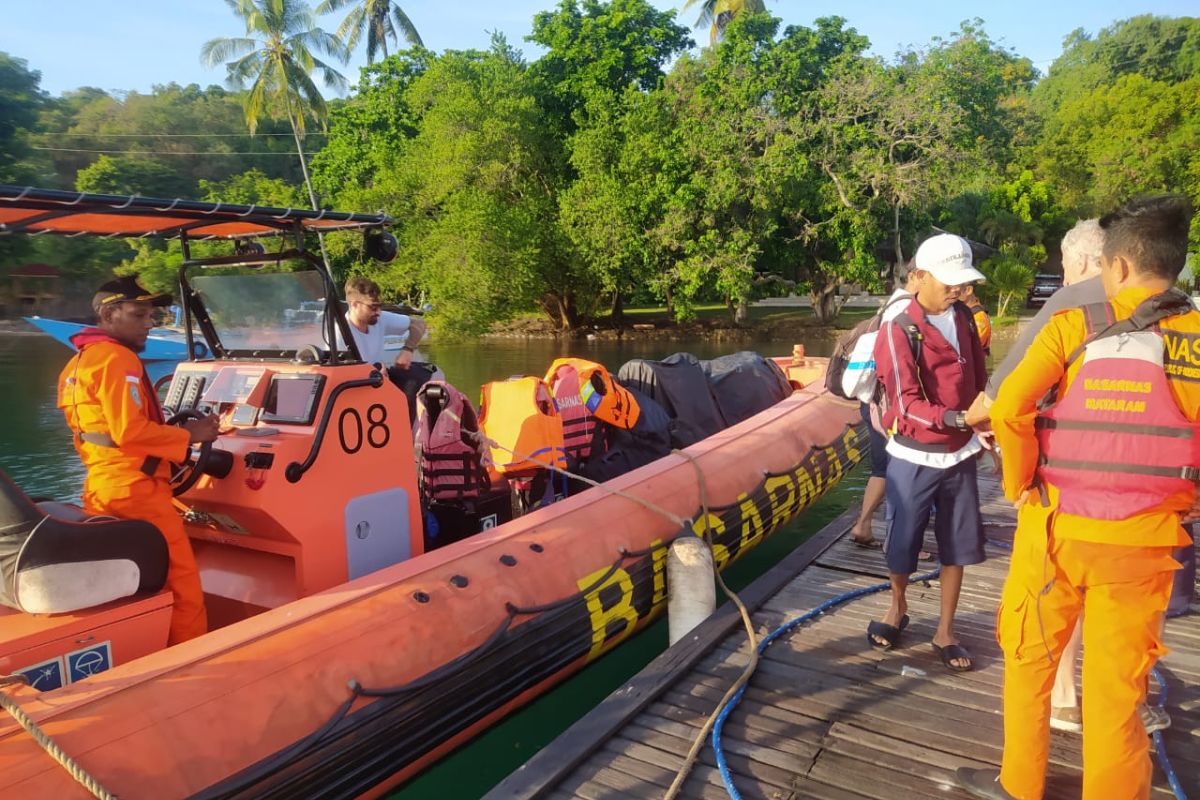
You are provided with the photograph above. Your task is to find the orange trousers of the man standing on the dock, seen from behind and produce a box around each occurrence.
[996,513,1178,800]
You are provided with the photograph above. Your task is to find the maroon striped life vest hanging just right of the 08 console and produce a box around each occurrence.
[413,380,490,500]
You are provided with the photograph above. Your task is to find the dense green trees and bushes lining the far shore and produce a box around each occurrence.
[0,10,1200,339]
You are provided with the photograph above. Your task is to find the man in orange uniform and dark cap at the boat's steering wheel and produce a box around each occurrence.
[59,277,217,644]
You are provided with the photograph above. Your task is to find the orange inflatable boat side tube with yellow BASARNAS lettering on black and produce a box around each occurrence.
[0,367,865,798]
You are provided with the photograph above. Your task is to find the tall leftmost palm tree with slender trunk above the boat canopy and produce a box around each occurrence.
[200,0,349,209]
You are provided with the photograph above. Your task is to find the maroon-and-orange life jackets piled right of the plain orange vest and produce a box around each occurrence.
[545,359,641,464]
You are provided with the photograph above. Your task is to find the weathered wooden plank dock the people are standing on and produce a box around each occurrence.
[487,469,1200,800]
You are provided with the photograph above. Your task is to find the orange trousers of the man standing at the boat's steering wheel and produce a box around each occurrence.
[83,477,209,644]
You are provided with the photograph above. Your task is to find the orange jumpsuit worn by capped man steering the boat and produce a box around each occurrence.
[58,336,208,644]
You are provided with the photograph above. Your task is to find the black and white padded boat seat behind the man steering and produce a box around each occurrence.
[0,470,167,614]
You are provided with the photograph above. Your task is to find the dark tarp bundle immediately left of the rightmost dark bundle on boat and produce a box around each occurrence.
[617,353,726,447]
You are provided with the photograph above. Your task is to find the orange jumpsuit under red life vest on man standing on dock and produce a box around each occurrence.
[991,288,1200,800]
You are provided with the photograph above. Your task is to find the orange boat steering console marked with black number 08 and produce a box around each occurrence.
[166,362,424,627]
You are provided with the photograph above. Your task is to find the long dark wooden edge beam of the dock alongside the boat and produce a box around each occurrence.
[485,506,858,800]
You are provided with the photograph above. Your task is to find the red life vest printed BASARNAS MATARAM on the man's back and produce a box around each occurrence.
[1037,295,1200,519]
